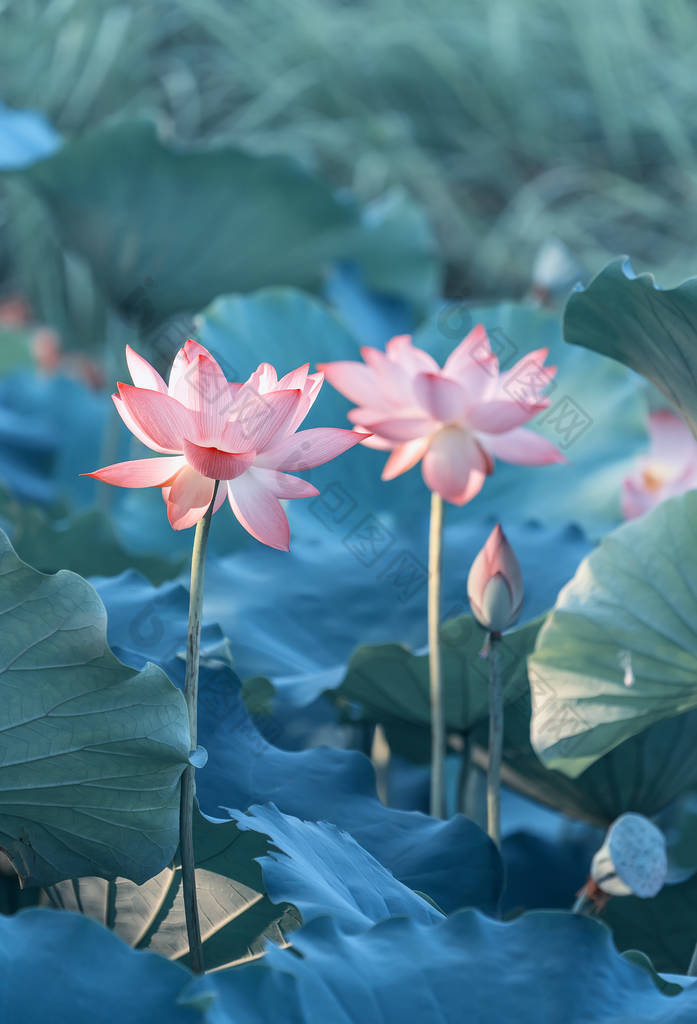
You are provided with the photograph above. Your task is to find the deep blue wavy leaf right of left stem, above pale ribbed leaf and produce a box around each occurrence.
[178,665,502,911]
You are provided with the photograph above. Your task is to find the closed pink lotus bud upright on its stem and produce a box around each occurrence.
[467,523,523,633]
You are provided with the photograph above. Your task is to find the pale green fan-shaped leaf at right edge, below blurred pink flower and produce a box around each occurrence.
[529,494,697,775]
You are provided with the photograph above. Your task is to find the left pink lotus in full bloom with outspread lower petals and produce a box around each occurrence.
[84,341,363,551]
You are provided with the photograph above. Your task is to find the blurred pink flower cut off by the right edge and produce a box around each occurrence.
[622,409,697,519]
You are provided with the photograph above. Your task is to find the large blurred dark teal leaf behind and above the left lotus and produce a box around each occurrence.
[17,122,437,335]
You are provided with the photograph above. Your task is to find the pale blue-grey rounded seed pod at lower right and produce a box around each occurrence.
[591,814,667,899]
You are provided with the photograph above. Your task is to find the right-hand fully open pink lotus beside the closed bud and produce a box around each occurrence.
[318,325,565,505]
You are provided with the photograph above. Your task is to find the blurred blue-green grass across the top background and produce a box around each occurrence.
[0,0,697,296]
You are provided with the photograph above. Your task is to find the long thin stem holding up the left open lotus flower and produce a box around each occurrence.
[179,481,219,974]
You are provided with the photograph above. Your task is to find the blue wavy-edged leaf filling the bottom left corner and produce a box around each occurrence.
[0,909,199,1024]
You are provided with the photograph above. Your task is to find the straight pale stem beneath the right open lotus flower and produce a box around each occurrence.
[428,492,445,818]
